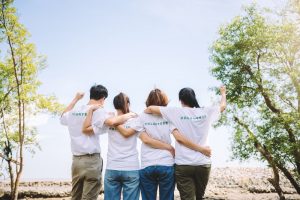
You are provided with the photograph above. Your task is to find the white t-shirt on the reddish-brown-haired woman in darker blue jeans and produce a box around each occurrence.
[132,113,175,169]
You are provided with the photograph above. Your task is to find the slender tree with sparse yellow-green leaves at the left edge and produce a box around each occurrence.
[0,0,61,199]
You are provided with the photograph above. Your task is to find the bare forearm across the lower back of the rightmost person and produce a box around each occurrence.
[172,129,211,157]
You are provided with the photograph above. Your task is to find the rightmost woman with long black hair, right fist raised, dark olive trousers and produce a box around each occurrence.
[145,86,226,200]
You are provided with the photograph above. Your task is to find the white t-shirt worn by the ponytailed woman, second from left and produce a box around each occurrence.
[92,110,140,171]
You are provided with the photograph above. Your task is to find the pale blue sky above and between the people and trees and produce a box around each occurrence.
[4,0,282,180]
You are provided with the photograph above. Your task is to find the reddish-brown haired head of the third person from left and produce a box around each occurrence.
[146,89,169,107]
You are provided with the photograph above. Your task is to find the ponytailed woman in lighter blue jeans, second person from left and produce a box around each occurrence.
[83,93,140,200]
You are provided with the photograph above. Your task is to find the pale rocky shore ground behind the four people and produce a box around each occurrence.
[0,167,300,200]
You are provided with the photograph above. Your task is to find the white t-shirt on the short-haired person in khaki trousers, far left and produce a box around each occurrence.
[60,105,103,155]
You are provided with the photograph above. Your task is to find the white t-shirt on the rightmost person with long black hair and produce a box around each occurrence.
[160,106,220,165]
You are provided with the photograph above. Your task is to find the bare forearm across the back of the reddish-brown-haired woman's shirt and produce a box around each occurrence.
[140,132,175,157]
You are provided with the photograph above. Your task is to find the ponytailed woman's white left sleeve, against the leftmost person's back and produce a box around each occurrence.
[92,109,109,135]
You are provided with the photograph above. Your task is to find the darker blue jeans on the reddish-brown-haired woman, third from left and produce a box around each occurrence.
[140,165,175,200]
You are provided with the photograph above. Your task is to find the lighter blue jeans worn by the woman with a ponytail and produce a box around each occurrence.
[104,169,140,200]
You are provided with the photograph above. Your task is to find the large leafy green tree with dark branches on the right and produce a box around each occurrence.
[211,2,300,199]
